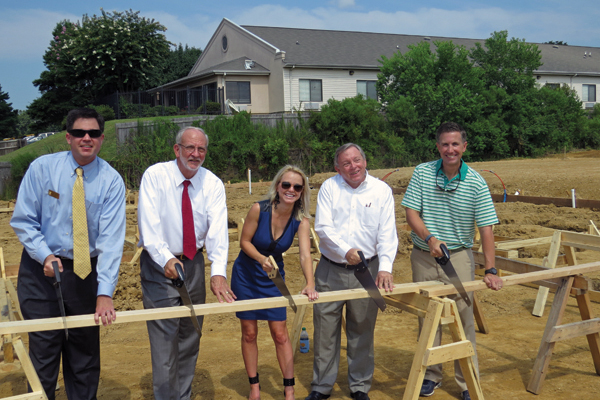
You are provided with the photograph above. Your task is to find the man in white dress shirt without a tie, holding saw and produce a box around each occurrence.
[306,143,398,400]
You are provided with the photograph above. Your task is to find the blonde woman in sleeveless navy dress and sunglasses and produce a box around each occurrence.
[231,165,319,400]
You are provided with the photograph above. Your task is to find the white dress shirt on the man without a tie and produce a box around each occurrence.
[315,173,398,272]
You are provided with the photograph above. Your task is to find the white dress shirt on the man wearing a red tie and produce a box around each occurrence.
[138,160,229,277]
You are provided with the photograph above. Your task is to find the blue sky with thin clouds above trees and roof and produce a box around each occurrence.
[0,0,600,110]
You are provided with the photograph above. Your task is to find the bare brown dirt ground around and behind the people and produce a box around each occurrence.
[0,151,600,400]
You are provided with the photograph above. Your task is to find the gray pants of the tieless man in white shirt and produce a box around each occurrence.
[312,257,379,394]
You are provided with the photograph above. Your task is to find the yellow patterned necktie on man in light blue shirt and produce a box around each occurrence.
[73,167,92,279]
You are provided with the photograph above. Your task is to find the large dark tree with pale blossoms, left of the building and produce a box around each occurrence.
[29,9,171,125]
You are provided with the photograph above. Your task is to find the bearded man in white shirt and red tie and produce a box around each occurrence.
[138,127,235,400]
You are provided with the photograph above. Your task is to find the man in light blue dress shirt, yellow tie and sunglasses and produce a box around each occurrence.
[10,108,125,400]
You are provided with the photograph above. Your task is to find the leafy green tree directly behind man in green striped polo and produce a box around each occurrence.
[377,41,484,162]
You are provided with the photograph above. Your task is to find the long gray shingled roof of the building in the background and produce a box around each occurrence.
[242,25,600,76]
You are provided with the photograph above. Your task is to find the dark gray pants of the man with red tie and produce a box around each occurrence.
[140,251,206,400]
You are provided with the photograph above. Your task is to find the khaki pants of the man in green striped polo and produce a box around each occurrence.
[410,248,479,392]
